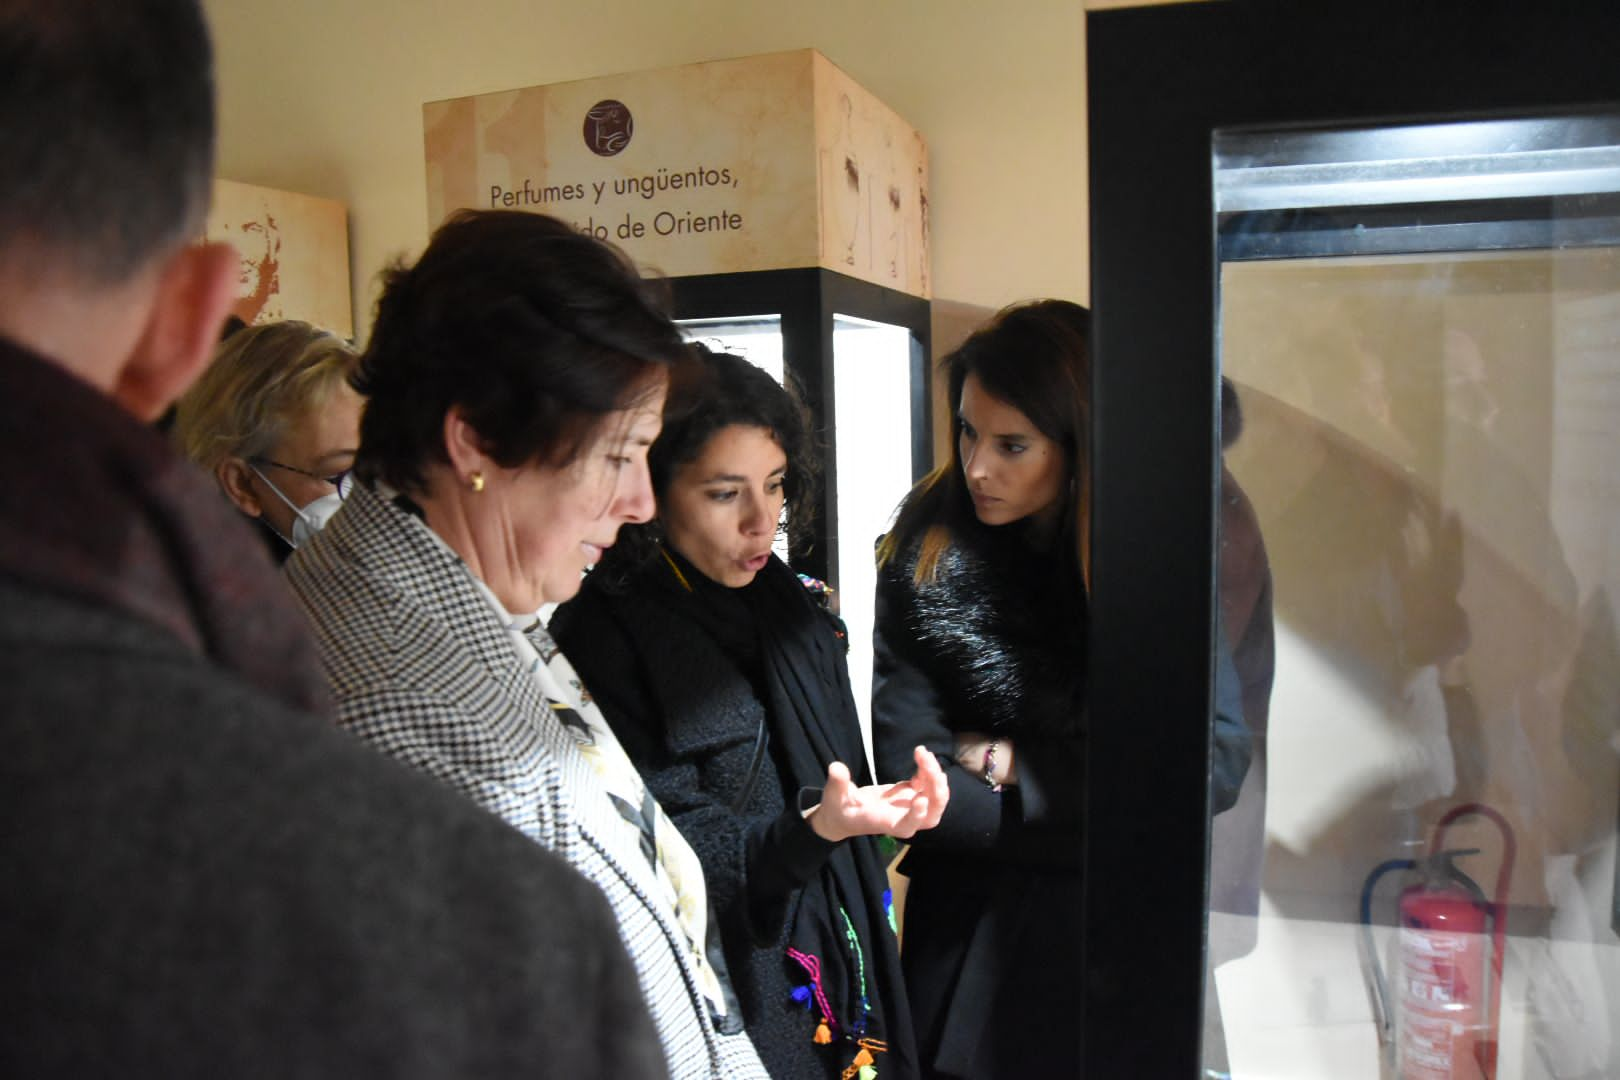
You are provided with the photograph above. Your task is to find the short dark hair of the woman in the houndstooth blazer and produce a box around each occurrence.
[353,210,685,492]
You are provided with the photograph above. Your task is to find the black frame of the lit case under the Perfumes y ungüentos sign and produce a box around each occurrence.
[669,269,933,589]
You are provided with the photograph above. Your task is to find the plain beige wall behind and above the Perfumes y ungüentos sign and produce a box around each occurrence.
[206,0,1090,334]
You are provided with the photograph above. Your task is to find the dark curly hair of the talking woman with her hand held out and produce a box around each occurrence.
[601,343,818,588]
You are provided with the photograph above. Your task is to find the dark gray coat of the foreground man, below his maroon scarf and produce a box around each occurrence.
[0,583,664,1080]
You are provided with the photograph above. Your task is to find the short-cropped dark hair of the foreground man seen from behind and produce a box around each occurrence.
[0,0,214,283]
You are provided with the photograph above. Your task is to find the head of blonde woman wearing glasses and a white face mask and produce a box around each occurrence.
[173,319,361,559]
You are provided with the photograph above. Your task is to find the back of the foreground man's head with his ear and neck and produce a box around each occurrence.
[0,0,238,419]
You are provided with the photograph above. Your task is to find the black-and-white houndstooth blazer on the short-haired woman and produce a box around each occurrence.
[287,486,766,1080]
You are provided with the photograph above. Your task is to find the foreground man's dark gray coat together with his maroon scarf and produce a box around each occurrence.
[0,342,666,1080]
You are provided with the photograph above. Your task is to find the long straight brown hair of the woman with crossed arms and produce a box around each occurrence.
[878,300,1092,583]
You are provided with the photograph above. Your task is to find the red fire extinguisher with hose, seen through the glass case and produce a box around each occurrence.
[1361,803,1515,1080]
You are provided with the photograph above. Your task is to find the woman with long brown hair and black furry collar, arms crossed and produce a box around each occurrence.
[873,300,1090,1077]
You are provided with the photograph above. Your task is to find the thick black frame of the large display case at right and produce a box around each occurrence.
[1077,0,1620,1078]
